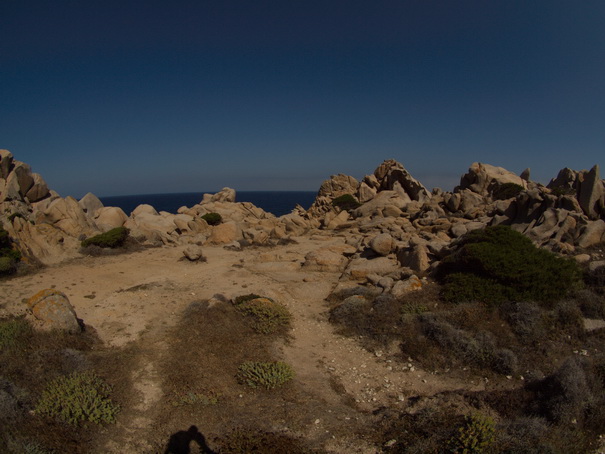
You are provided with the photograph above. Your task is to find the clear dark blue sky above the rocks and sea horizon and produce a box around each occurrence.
[0,0,605,197]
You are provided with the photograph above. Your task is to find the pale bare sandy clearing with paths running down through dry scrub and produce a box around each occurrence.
[0,236,494,452]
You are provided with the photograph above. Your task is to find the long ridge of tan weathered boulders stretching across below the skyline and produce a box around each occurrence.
[0,150,605,278]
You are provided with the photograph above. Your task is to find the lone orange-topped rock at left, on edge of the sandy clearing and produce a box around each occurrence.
[27,289,81,333]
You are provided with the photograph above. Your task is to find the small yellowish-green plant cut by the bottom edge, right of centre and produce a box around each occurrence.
[447,415,496,454]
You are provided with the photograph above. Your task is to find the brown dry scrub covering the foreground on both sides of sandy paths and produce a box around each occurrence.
[0,231,605,454]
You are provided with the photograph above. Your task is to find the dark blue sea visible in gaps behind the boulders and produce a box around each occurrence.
[99,191,317,216]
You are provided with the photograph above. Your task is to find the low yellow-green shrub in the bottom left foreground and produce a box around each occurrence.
[36,372,120,425]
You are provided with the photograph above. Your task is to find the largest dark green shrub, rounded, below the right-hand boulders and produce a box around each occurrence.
[438,226,582,303]
